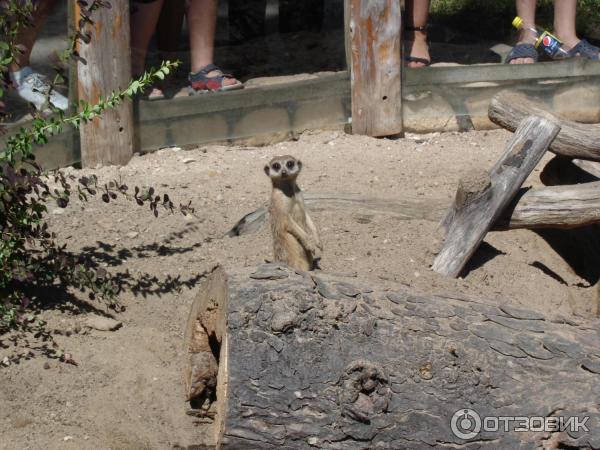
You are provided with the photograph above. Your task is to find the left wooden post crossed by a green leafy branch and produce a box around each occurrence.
[75,0,133,167]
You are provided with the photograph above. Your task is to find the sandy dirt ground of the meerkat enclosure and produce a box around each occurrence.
[0,131,598,450]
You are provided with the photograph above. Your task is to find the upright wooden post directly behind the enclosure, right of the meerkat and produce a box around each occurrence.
[345,0,402,136]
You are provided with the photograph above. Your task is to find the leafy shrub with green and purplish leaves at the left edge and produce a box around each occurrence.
[0,0,193,355]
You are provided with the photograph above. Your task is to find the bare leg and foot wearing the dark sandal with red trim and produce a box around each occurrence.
[187,0,240,90]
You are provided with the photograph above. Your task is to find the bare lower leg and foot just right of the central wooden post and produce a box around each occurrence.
[404,0,431,67]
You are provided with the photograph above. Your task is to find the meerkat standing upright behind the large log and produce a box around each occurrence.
[265,155,323,270]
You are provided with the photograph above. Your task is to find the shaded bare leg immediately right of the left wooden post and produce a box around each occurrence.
[131,0,163,77]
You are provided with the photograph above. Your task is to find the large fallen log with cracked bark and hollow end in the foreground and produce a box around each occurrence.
[190,265,600,450]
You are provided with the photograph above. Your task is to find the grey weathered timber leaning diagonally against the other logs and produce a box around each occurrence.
[432,117,560,277]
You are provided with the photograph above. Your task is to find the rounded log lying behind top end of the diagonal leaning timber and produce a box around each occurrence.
[488,91,600,161]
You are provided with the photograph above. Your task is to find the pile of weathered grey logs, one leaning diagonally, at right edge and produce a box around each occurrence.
[432,91,600,277]
